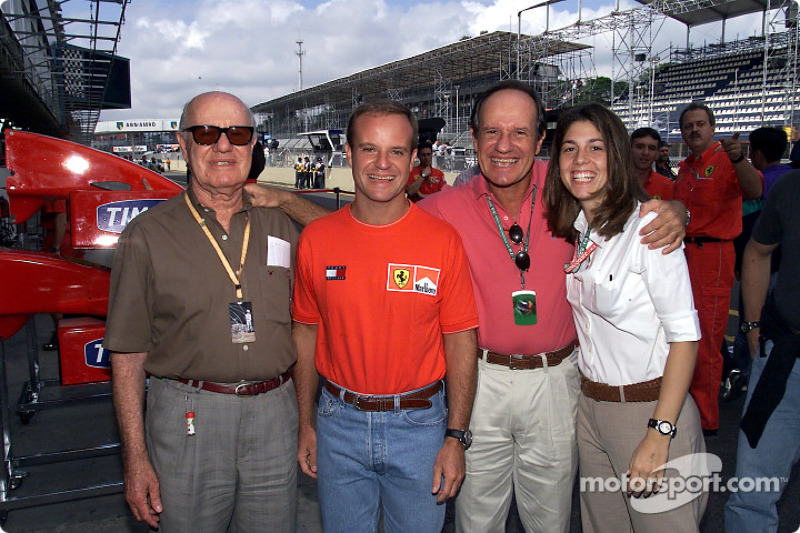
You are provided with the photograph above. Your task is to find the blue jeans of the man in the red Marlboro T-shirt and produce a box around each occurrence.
[317,380,447,533]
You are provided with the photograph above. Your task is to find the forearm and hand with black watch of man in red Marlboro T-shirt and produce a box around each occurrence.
[431,329,478,503]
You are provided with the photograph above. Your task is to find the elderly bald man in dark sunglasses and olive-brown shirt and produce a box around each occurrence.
[104,92,298,533]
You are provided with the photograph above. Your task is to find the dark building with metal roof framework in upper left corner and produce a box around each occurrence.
[0,0,130,144]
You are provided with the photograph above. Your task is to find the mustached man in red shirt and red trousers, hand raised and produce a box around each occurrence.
[674,102,764,435]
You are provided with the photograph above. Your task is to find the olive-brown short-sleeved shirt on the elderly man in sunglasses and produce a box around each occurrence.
[103,192,298,383]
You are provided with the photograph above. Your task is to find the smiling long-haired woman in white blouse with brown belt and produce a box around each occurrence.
[545,104,707,533]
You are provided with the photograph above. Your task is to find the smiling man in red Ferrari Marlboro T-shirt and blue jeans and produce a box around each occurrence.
[292,100,478,533]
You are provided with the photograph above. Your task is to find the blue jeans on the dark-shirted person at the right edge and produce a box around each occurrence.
[725,342,800,533]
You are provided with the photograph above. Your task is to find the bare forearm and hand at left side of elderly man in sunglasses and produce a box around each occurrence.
[111,353,163,529]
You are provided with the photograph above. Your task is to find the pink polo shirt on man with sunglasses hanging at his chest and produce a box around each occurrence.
[417,160,576,355]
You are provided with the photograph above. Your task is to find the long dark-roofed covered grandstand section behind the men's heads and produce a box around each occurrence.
[253,31,586,145]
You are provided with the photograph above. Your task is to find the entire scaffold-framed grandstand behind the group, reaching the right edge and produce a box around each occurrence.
[253,0,800,159]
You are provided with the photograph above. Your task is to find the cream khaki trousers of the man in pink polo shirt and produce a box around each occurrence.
[456,350,580,533]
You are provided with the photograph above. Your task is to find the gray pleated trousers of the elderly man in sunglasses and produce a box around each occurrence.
[146,377,298,533]
